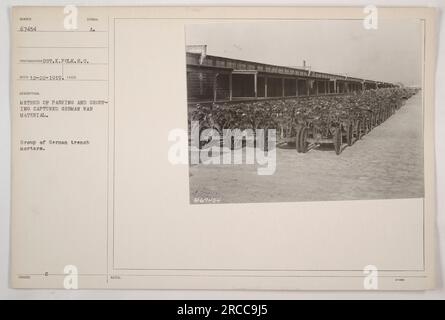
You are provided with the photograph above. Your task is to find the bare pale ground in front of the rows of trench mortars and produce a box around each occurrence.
[190,93,424,203]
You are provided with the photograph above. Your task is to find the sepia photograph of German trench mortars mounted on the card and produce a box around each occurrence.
[185,19,424,204]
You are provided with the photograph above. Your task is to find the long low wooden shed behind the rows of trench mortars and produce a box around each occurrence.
[186,52,395,102]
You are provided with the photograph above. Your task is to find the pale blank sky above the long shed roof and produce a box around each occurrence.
[186,19,423,86]
